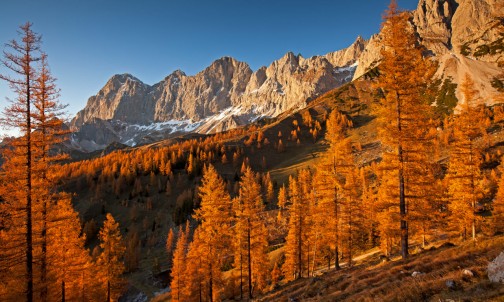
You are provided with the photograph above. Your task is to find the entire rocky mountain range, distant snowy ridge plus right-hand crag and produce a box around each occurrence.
[69,0,504,152]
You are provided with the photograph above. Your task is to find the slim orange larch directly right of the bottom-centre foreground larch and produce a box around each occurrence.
[233,167,268,299]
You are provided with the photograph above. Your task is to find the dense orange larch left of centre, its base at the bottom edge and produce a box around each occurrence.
[194,165,233,301]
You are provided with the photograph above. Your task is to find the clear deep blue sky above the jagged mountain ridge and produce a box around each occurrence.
[0,0,418,115]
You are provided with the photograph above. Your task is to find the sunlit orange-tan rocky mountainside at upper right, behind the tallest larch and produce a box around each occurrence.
[354,0,504,105]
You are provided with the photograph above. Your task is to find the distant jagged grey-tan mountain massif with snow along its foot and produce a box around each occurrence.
[72,37,366,151]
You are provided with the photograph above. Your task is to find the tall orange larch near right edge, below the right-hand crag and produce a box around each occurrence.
[446,75,486,239]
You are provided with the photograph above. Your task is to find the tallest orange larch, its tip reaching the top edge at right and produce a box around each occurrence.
[376,0,435,258]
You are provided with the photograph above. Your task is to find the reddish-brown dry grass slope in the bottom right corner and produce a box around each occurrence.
[259,236,504,301]
